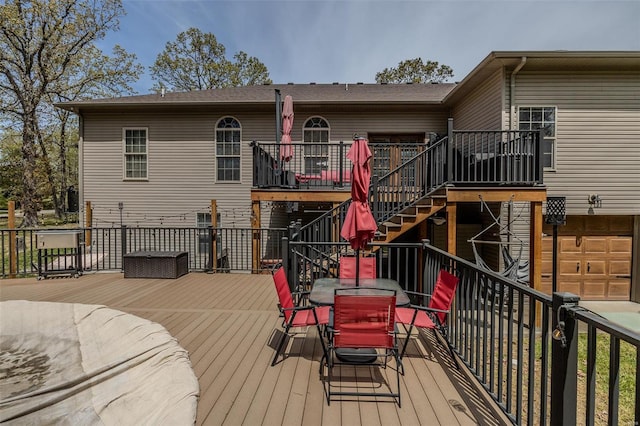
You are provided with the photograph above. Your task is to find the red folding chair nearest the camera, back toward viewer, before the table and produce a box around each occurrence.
[321,288,402,406]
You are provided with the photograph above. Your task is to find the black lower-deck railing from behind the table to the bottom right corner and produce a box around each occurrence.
[284,239,640,425]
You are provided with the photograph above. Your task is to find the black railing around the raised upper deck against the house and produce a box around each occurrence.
[251,120,543,190]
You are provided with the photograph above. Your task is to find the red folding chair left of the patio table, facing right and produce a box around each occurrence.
[271,268,330,366]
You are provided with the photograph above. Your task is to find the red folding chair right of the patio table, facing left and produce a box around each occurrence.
[396,269,459,367]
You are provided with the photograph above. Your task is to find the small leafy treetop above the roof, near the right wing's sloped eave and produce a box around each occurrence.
[376,58,453,83]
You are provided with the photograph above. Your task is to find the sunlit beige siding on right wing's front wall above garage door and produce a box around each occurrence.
[515,72,640,215]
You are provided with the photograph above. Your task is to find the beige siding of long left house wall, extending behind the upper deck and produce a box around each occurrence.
[82,105,447,228]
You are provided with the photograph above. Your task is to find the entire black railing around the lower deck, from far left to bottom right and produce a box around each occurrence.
[0,227,640,425]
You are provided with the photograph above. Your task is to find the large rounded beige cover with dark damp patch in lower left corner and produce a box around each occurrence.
[0,301,199,425]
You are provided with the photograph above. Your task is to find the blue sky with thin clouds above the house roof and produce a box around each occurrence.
[99,0,640,93]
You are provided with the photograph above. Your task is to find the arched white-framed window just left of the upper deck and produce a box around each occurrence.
[216,117,242,182]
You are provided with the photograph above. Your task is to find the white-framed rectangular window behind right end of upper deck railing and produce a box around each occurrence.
[518,106,556,169]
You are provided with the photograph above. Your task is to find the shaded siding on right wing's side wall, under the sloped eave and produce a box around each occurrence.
[452,70,504,130]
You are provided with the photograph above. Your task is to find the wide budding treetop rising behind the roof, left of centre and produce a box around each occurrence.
[150,28,271,92]
